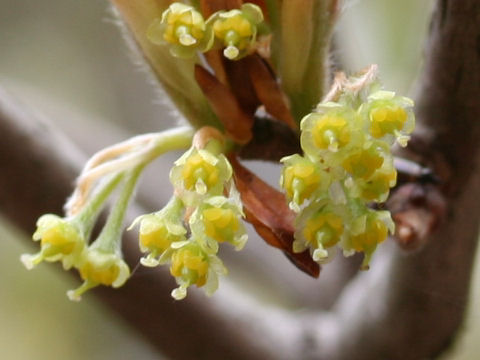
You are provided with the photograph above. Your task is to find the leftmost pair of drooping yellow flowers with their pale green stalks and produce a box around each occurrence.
[20,169,140,301]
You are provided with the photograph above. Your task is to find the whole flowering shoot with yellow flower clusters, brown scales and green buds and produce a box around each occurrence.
[22,0,415,300]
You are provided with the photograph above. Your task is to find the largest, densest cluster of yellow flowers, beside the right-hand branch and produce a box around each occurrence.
[280,78,414,268]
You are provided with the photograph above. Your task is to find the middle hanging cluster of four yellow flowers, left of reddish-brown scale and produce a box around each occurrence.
[137,139,247,300]
